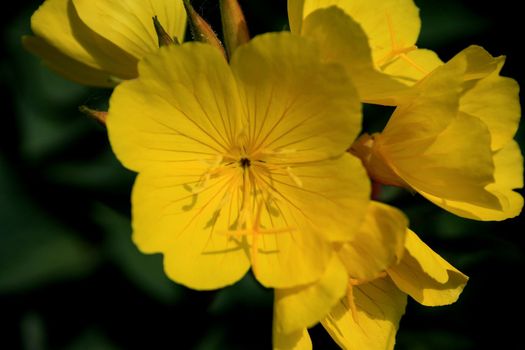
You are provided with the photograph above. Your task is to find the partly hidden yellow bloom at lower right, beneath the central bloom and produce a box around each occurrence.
[274,212,468,350]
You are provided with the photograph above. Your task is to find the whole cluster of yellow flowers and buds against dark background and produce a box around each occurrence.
[24,0,523,349]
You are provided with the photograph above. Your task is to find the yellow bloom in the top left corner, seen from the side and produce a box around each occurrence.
[23,0,186,87]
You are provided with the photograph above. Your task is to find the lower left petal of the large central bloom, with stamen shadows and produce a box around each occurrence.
[132,162,250,290]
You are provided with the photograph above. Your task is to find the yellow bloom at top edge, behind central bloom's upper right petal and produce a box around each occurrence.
[288,0,442,105]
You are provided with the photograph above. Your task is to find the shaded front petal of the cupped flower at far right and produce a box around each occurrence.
[374,55,500,209]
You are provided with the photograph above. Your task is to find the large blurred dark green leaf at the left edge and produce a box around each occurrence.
[0,158,98,293]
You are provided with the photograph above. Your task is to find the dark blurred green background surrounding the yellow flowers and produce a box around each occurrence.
[0,0,525,350]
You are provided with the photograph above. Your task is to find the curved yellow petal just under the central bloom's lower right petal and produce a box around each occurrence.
[274,255,348,334]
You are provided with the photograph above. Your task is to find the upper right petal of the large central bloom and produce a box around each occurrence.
[231,33,361,162]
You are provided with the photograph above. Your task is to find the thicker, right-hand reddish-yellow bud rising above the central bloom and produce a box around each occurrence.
[220,0,250,57]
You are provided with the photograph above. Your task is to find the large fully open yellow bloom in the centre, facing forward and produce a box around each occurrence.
[107,33,370,290]
